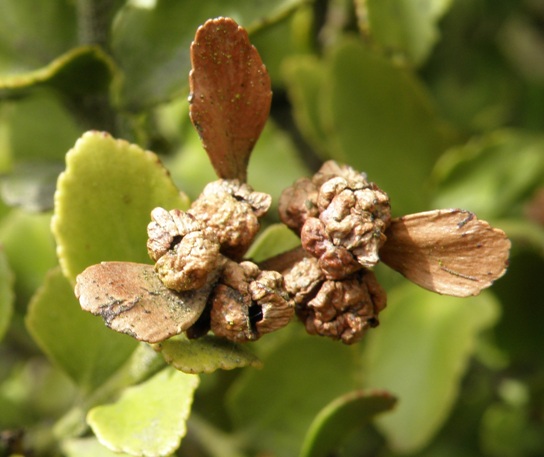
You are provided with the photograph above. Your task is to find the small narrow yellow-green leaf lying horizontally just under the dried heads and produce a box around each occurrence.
[153,335,262,374]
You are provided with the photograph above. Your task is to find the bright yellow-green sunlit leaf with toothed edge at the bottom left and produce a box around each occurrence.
[87,368,199,457]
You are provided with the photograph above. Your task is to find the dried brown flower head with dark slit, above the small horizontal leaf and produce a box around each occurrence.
[210,261,294,342]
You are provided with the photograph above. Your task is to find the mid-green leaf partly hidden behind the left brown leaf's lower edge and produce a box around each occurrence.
[25,269,137,390]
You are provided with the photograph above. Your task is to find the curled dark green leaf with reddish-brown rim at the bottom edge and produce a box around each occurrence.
[300,390,396,457]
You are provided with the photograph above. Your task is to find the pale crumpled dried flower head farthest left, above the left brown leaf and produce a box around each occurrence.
[147,208,220,292]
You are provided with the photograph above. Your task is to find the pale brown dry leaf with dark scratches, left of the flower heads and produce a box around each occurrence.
[75,262,209,343]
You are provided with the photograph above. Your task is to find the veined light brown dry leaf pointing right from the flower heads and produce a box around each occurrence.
[380,209,510,297]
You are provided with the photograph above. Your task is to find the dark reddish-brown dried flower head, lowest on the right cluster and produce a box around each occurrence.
[297,269,387,344]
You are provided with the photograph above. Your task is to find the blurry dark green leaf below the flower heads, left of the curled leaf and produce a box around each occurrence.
[227,331,357,457]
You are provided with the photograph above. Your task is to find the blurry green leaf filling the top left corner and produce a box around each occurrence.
[0,0,77,75]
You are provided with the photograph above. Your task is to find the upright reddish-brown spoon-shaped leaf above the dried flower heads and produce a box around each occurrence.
[189,17,272,182]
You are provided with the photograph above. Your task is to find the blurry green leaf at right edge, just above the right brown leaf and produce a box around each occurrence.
[433,131,544,219]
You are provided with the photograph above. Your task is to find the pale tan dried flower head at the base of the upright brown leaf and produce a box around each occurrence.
[187,179,272,260]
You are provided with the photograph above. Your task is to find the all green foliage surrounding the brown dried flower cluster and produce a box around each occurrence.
[0,0,544,457]
